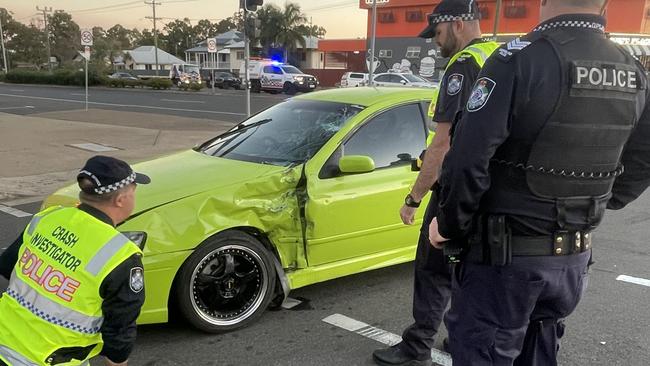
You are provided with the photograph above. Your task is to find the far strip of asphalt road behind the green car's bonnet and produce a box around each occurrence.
[0,83,286,122]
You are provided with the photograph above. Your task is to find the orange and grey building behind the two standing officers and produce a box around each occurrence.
[359,0,650,79]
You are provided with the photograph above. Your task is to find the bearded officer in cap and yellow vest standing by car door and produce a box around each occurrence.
[373,0,498,365]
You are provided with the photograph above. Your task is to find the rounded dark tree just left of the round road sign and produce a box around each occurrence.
[47,10,81,64]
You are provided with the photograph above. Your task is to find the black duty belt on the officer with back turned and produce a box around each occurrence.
[510,231,591,256]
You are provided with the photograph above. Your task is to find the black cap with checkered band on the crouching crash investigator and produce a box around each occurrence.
[77,155,151,194]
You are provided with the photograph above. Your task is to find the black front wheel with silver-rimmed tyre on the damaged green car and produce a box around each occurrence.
[176,231,276,333]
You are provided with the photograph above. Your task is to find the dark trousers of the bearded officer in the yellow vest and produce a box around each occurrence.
[400,193,451,359]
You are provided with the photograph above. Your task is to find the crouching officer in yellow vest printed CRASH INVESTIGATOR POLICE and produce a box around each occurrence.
[0,156,150,366]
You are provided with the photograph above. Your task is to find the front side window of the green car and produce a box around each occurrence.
[343,104,426,169]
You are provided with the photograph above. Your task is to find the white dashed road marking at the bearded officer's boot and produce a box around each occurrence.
[323,314,451,366]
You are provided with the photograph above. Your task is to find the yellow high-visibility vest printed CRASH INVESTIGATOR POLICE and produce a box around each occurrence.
[0,206,142,366]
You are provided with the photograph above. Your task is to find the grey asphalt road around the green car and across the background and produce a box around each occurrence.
[0,84,650,366]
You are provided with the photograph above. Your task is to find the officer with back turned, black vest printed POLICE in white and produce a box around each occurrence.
[430,0,650,366]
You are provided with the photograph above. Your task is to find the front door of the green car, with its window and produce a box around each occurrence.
[305,103,426,266]
